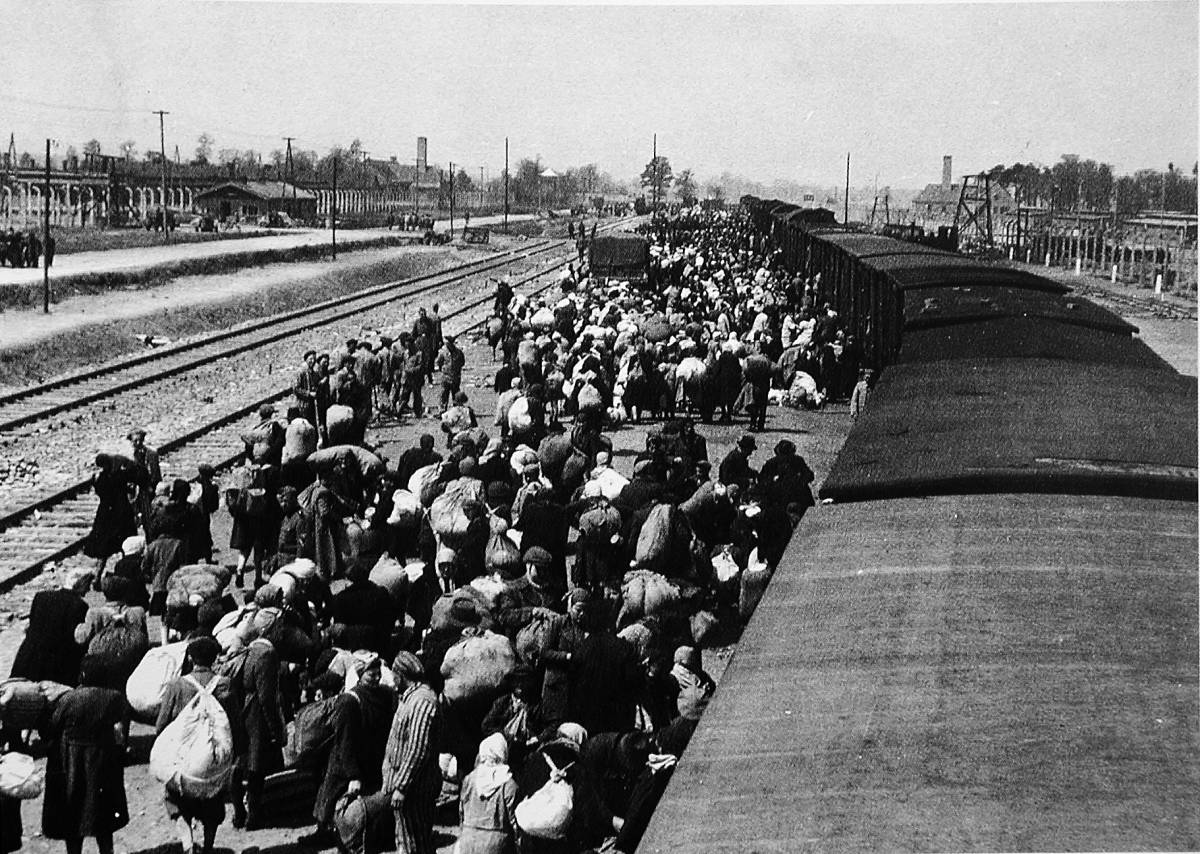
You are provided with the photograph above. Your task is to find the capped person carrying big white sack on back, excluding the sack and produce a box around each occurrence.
[155,637,240,854]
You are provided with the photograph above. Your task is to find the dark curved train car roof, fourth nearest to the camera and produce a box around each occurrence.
[904,283,1138,336]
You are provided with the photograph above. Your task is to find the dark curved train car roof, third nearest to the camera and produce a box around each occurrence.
[896,315,1172,371]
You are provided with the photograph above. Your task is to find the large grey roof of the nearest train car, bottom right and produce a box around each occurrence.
[637,494,1200,854]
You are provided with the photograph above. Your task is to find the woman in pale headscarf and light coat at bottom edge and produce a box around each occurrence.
[455,733,517,854]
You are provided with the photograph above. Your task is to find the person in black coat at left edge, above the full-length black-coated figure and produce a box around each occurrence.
[8,567,92,687]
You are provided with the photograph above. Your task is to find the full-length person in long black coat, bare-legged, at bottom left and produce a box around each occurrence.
[42,656,130,854]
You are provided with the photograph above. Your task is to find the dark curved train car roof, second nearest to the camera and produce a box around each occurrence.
[821,359,1196,501]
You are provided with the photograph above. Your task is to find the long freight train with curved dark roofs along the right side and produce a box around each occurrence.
[638,199,1200,854]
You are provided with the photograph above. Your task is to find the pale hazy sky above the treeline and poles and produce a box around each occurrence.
[0,0,1200,187]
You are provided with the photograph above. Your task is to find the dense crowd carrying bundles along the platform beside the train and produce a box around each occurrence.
[0,211,859,854]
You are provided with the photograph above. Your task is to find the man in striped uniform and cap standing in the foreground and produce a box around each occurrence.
[383,651,442,854]
